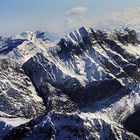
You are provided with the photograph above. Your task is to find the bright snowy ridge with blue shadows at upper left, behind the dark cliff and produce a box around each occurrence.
[0,31,56,64]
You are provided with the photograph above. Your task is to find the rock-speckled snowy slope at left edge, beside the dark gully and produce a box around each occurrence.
[0,59,45,118]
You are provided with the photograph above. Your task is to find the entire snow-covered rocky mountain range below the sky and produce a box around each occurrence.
[0,27,140,140]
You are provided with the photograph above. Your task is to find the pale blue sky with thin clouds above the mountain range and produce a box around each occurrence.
[0,0,140,35]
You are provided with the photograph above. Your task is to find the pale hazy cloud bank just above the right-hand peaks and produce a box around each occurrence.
[65,7,140,34]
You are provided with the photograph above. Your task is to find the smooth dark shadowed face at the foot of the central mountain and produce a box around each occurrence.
[63,79,124,106]
